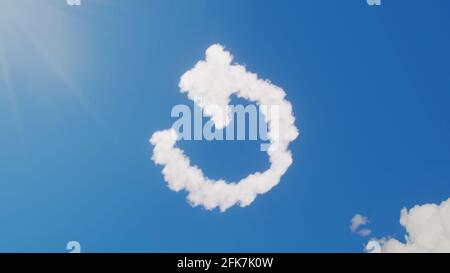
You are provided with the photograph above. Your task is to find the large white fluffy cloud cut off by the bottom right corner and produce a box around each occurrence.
[367,198,450,252]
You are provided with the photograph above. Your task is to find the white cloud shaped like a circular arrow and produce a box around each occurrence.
[150,44,298,211]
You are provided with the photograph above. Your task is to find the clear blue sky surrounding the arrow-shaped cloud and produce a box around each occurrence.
[0,0,450,252]
